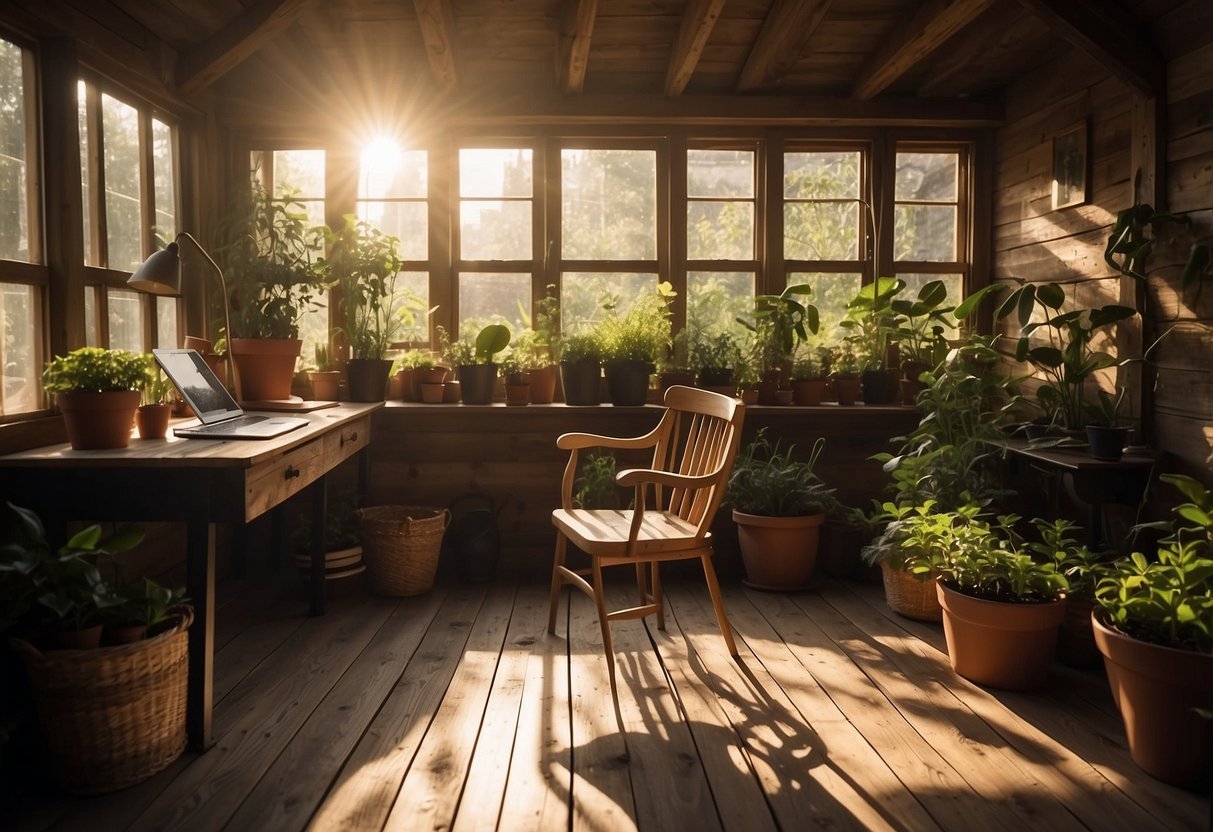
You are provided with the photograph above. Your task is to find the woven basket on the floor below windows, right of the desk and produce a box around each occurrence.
[357,506,451,597]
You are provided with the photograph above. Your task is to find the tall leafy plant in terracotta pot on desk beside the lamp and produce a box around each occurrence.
[216,182,325,401]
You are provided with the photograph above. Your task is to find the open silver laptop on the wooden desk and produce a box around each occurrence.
[152,349,308,439]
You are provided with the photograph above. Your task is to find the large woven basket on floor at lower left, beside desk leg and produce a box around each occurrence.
[12,606,194,794]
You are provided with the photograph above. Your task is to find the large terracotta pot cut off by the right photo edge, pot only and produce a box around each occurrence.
[1090,615,1213,787]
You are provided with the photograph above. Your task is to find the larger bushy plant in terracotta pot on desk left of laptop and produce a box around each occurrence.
[42,347,148,450]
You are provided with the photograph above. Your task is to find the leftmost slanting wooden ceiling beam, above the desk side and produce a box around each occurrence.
[177,0,315,96]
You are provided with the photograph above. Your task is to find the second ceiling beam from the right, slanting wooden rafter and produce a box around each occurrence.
[852,0,992,101]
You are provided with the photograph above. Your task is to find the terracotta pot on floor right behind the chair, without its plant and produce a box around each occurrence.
[733,509,826,591]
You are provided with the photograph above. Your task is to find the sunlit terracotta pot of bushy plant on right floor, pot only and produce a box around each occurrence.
[935,582,1065,690]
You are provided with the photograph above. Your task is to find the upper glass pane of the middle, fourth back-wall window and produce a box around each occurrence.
[560,148,657,260]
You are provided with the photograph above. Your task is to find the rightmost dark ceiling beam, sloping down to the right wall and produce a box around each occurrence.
[1019,0,1167,97]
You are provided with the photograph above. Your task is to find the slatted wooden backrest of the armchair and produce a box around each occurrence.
[653,384,746,535]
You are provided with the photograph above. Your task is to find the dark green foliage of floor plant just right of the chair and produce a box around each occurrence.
[727,428,837,517]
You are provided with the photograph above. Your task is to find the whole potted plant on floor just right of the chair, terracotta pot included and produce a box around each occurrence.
[727,428,836,589]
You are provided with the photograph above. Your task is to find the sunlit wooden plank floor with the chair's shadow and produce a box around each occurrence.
[0,567,1209,832]
